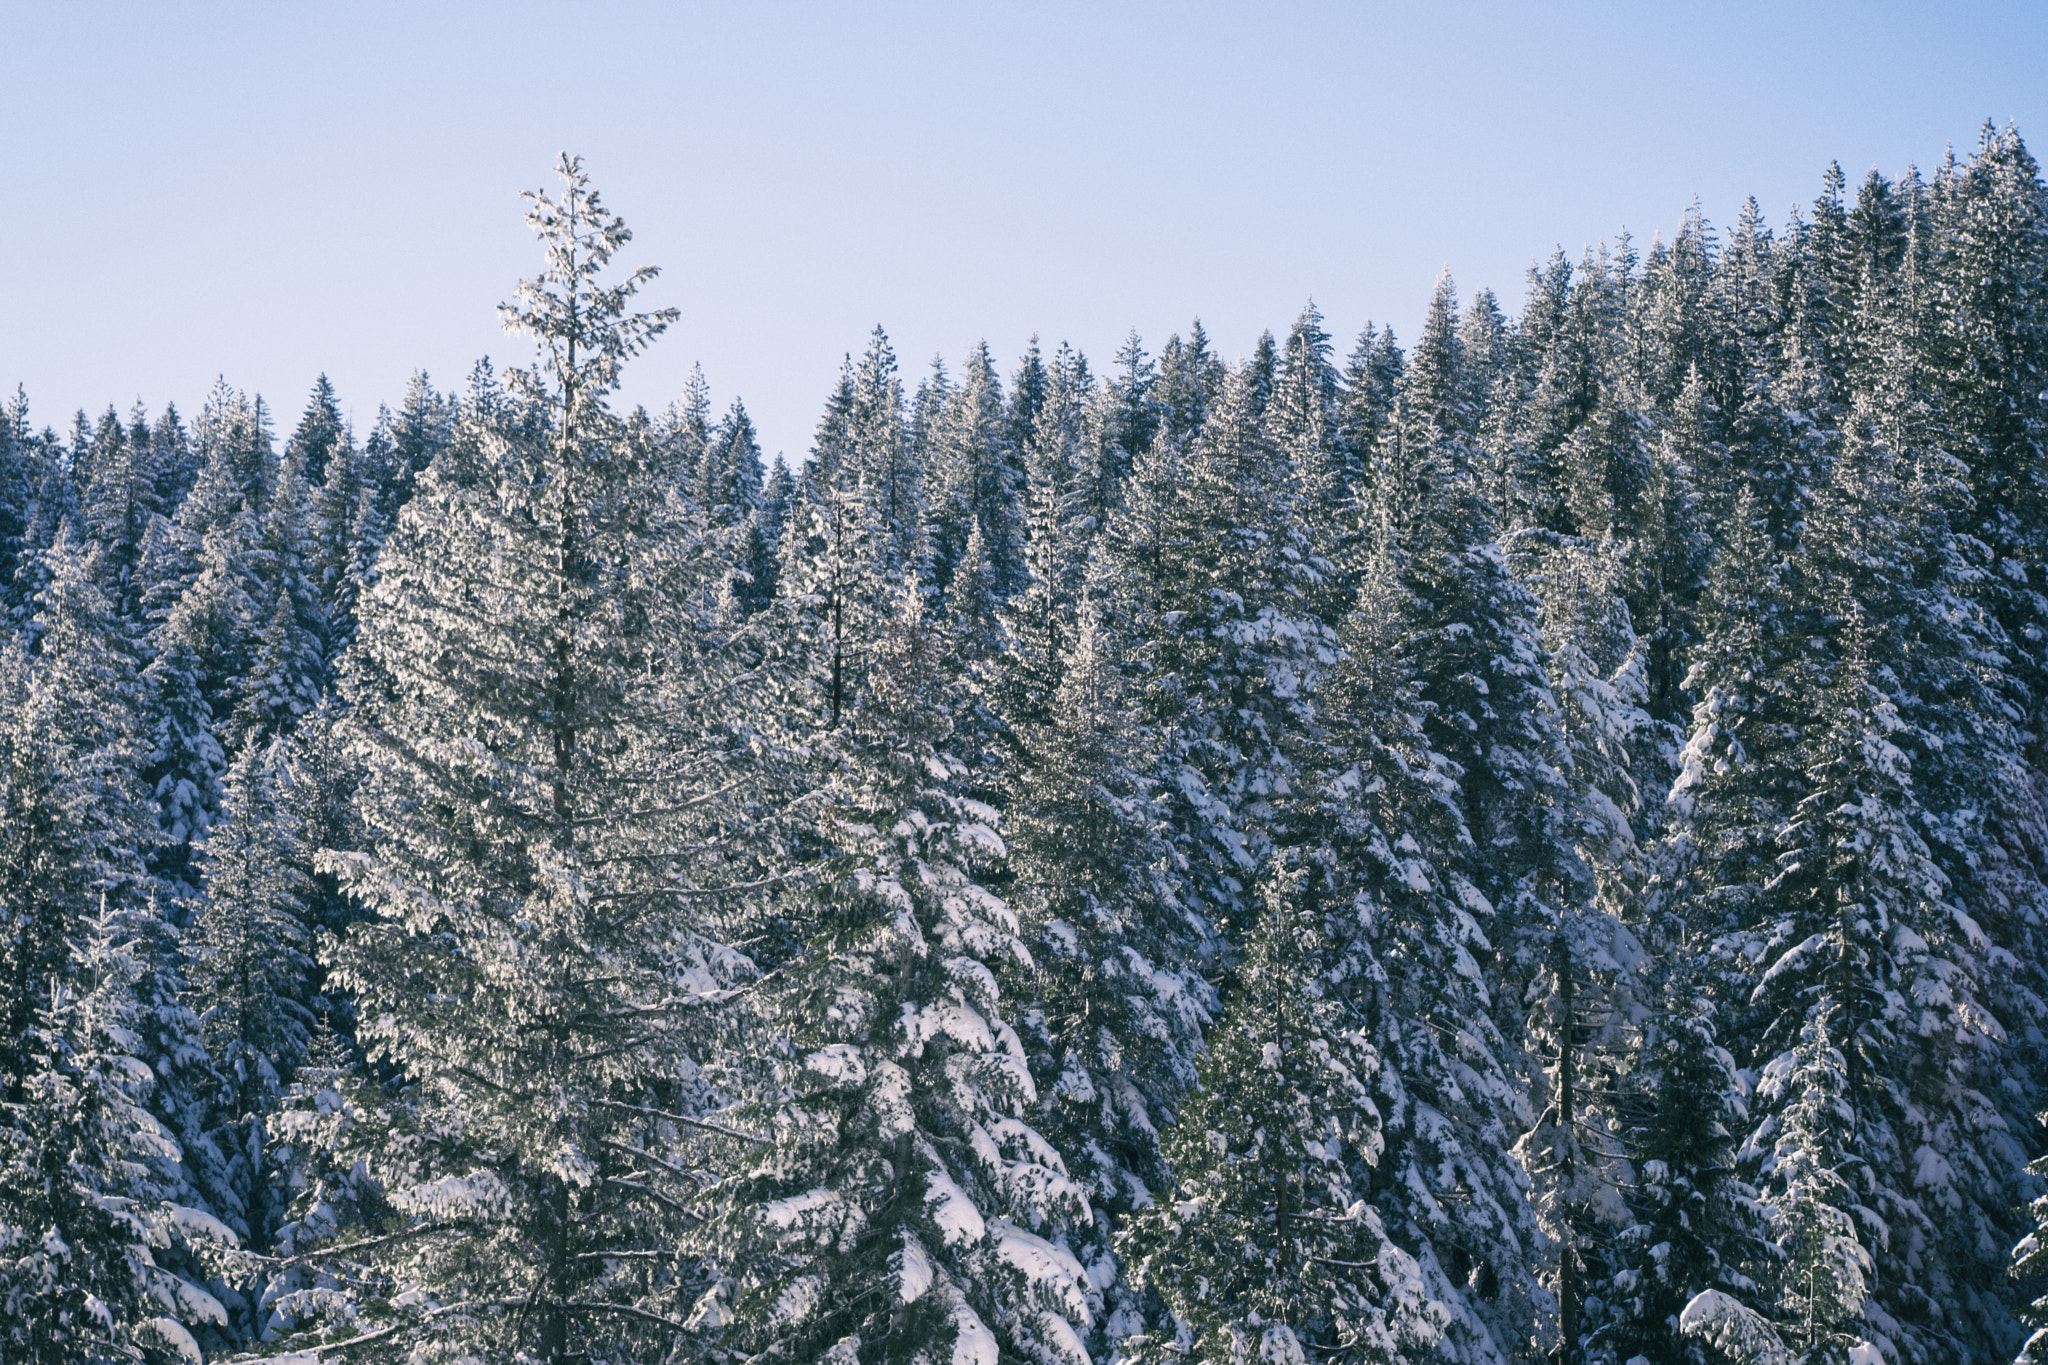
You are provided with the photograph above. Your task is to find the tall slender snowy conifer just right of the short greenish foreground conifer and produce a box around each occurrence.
[1305,517,1542,1361]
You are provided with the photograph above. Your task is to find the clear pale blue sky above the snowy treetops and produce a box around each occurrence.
[0,0,2048,458]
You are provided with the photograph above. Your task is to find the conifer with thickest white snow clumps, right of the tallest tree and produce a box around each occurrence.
[692,583,1092,1365]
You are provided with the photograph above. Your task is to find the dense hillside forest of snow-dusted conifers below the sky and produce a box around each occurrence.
[0,136,2048,1365]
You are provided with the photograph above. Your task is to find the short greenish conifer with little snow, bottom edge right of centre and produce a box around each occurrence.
[1122,866,1450,1365]
